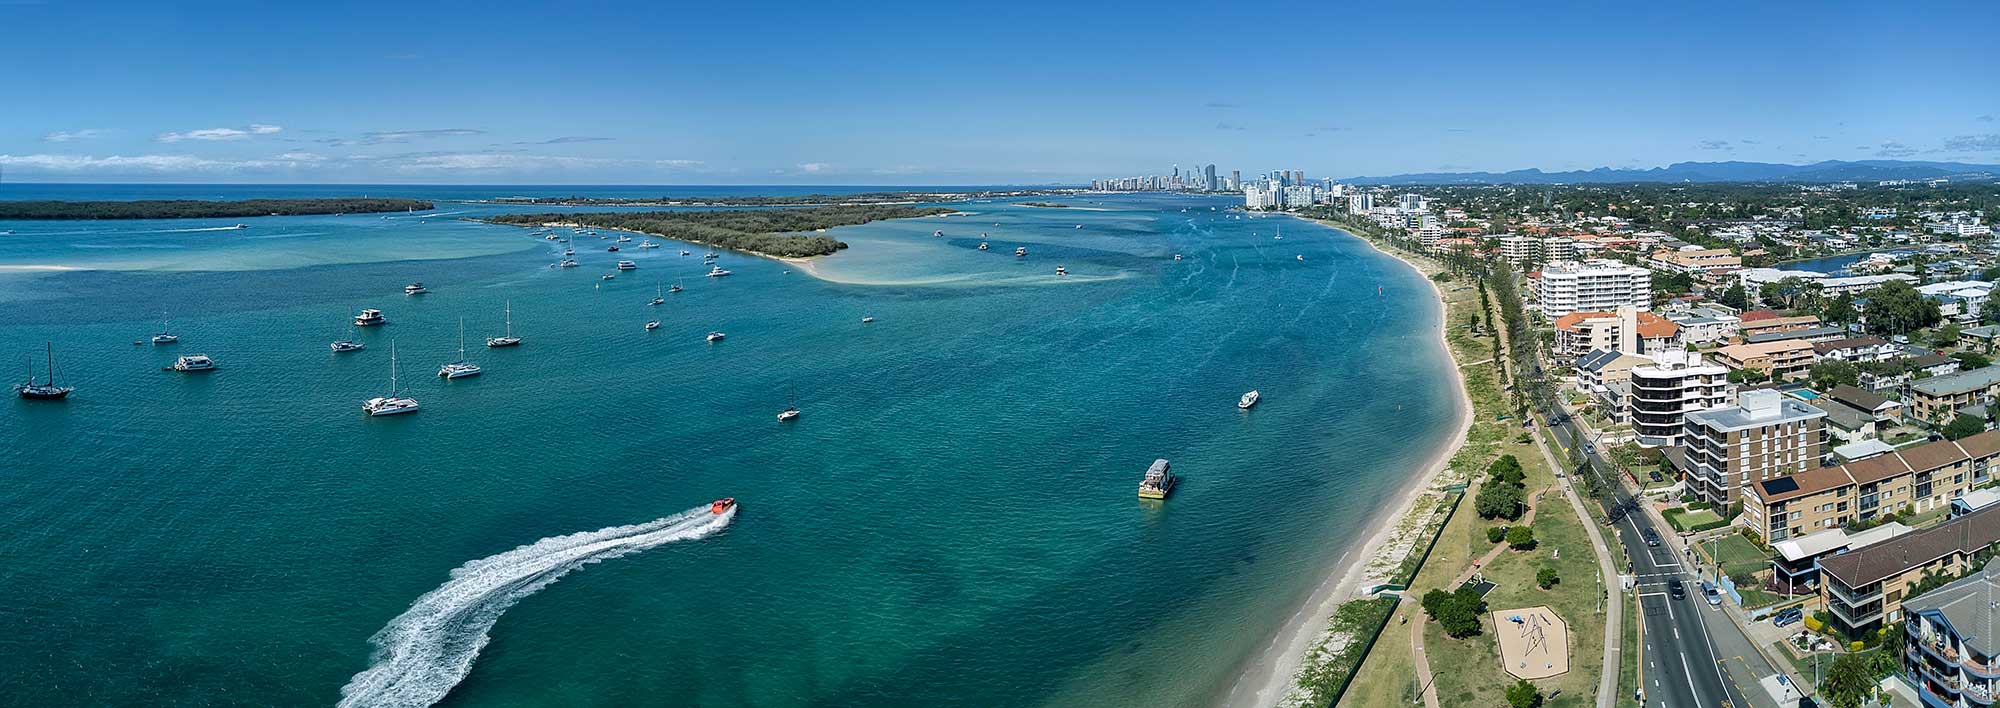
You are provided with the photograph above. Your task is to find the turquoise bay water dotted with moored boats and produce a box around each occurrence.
[0,186,1452,706]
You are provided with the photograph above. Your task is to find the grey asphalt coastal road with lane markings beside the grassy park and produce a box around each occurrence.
[1550,410,1772,708]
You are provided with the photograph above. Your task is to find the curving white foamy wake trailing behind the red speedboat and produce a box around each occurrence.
[340,506,736,708]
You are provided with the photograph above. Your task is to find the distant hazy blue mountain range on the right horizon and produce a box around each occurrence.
[1340,160,2000,184]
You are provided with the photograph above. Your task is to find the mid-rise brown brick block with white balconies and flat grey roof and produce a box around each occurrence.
[1680,390,1826,508]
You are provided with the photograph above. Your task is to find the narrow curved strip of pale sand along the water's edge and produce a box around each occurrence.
[1224,220,1472,706]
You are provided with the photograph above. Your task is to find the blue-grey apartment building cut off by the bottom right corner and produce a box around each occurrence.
[1896,560,2000,708]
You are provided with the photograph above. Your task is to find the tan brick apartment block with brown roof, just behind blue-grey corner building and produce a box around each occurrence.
[1820,508,2000,636]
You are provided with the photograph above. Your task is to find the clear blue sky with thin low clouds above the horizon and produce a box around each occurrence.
[0,0,2000,184]
